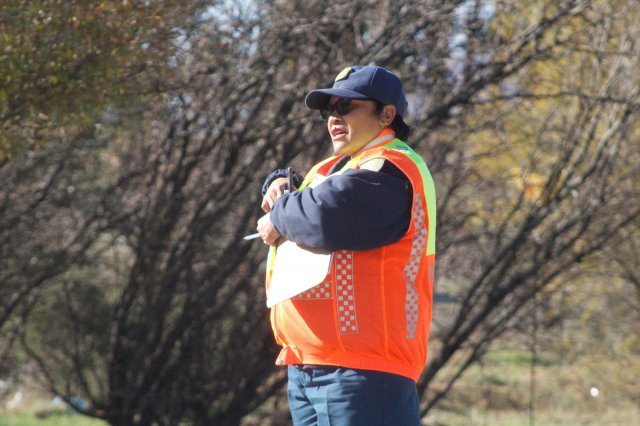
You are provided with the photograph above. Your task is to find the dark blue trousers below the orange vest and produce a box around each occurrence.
[288,365,420,426]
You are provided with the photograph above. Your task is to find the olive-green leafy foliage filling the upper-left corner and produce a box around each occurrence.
[0,0,184,165]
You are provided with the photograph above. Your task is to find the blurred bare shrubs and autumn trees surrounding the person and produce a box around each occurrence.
[0,0,640,426]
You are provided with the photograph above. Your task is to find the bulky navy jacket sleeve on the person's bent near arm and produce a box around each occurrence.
[271,161,413,251]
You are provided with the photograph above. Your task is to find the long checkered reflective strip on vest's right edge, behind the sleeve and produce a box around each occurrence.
[403,194,427,339]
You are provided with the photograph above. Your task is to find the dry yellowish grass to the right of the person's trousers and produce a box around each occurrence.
[424,351,640,426]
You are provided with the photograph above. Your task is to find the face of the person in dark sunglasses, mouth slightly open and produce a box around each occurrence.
[327,96,383,155]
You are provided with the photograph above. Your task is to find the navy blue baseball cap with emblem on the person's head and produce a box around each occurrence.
[304,65,408,117]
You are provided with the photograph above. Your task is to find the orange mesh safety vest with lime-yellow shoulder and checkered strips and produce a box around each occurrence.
[267,131,435,381]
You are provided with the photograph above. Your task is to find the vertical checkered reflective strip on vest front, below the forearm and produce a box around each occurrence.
[333,250,358,334]
